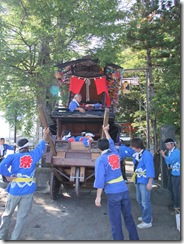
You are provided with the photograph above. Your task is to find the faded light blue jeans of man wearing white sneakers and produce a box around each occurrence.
[136,183,152,223]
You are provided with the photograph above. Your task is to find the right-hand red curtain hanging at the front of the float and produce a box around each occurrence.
[94,77,111,106]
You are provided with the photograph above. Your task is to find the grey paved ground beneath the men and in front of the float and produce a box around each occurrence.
[0,162,180,241]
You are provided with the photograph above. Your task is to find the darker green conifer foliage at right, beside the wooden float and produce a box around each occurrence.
[115,1,180,147]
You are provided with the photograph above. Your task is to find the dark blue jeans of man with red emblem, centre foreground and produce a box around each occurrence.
[107,191,139,240]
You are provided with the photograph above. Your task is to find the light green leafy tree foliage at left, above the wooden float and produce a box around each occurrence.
[0,0,128,137]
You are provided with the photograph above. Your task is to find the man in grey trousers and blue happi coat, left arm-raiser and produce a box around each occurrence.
[0,128,49,240]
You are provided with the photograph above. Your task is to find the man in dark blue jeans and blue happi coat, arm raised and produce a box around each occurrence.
[94,125,139,240]
